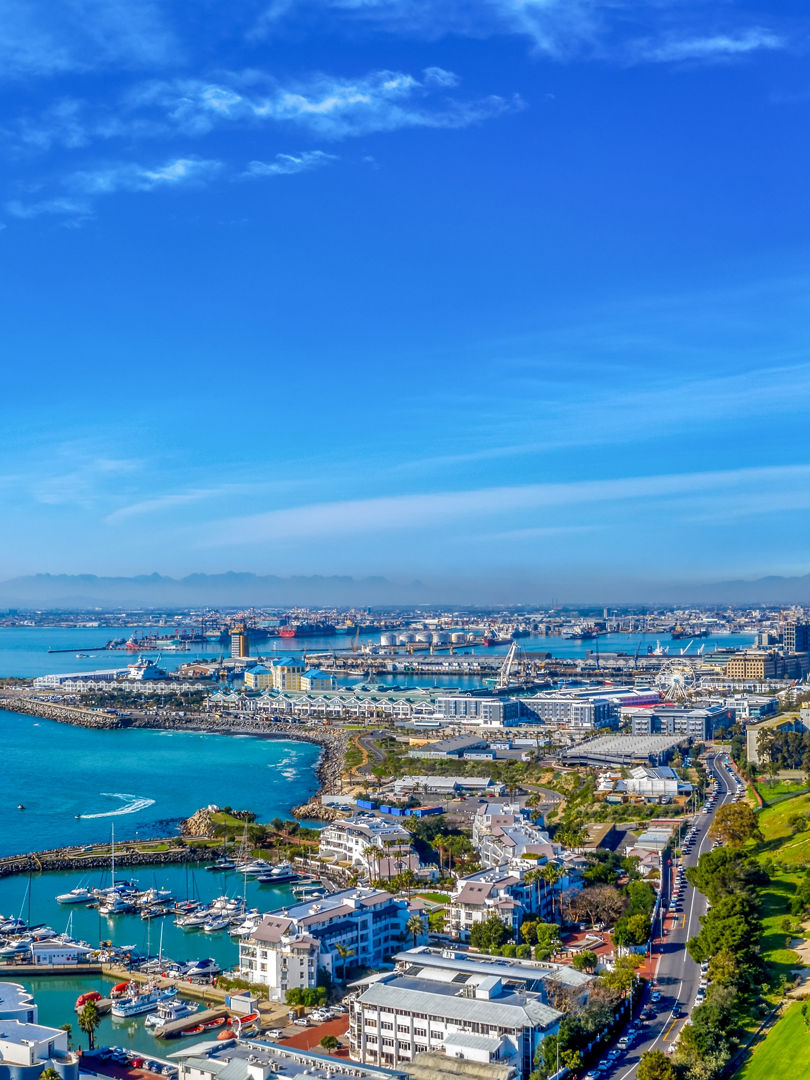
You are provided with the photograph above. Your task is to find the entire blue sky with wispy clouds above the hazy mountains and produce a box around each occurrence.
[0,0,810,598]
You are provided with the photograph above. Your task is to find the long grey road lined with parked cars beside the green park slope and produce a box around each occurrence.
[604,753,737,1080]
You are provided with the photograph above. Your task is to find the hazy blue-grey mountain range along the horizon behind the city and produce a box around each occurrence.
[0,572,810,610]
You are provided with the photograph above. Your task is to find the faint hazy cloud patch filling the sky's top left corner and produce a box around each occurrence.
[0,0,179,79]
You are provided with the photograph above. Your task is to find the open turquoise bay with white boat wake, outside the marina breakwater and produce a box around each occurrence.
[0,712,320,854]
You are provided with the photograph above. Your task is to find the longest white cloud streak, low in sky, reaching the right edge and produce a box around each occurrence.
[199,464,810,548]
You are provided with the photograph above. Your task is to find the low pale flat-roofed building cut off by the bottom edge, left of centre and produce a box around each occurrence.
[171,1038,406,1080]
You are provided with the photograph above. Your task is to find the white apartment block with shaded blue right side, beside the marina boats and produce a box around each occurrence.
[239,889,419,1001]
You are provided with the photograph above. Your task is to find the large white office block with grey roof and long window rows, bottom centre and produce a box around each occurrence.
[349,957,563,1080]
